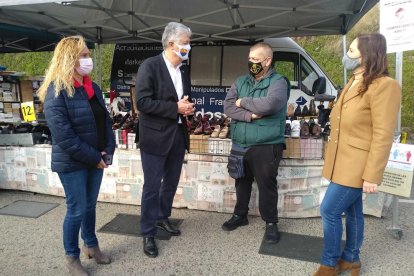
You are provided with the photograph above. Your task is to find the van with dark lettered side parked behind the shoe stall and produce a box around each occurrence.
[111,38,338,116]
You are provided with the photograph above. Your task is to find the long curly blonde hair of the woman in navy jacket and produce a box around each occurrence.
[38,36,86,102]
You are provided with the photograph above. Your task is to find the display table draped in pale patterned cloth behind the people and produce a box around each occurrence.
[0,145,386,218]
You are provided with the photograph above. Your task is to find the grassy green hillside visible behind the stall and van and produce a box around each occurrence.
[0,5,414,133]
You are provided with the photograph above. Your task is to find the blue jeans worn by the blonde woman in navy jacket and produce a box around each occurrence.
[58,169,103,257]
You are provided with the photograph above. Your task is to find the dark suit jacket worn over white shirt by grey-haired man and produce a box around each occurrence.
[135,53,191,156]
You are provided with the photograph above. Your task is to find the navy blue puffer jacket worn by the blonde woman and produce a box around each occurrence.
[44,83,115,172]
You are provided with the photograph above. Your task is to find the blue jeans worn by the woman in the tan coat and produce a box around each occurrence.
[321,182,364,266]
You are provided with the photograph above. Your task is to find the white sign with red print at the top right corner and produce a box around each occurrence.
[380,0,414,53]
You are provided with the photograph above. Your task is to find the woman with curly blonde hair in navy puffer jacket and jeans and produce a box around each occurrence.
[39,36,115,275]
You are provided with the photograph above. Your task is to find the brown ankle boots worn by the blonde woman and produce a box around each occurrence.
[65,246,111,276]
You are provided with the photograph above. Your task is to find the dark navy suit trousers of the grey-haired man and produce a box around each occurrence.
[141,125,186,237]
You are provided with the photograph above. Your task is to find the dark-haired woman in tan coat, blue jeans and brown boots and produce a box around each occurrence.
[314,34,401,276]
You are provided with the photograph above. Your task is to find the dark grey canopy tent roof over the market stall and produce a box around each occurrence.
[0,0,378,52]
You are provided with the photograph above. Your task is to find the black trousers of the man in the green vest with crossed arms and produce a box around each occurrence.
[234,144,284,223]
